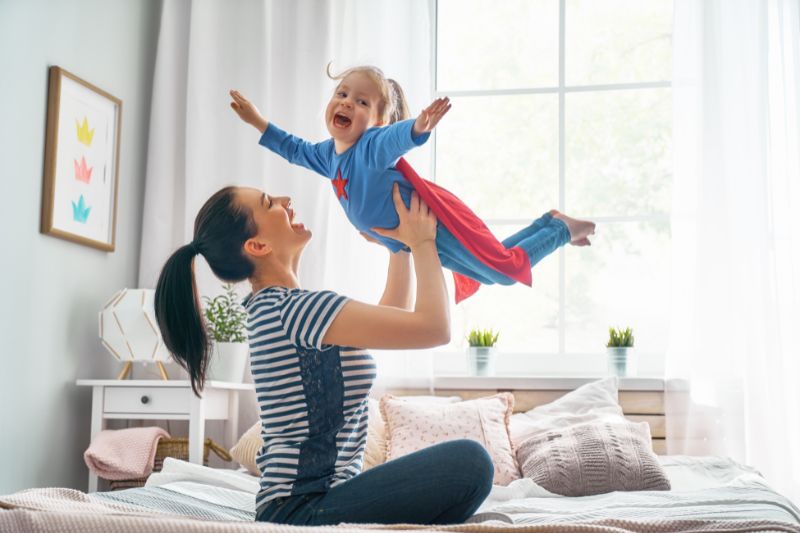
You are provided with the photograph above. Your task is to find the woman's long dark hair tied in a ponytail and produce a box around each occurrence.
[155,187,257,396]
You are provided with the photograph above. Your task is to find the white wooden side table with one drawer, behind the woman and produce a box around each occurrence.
[77,379,254,492]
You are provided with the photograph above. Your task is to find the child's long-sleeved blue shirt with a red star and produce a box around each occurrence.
[259,119,430,252]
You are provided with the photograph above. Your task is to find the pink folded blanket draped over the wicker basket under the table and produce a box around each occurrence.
[83,427,169,480]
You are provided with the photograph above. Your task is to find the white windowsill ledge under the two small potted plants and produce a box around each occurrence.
[433,375,664,391]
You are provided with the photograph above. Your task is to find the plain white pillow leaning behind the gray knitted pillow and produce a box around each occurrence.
[509,377,624,448]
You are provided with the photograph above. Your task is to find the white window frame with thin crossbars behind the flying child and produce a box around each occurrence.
[430,0,672,376]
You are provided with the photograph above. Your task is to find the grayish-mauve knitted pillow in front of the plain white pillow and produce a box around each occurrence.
[517,420,670,496]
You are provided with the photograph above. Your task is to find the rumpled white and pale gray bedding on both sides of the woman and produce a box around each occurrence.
[90,456,800,533]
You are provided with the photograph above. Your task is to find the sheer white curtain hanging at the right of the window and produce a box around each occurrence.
[667,0,800,502]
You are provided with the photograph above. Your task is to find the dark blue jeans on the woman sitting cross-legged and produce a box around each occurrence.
[256,439,494,526]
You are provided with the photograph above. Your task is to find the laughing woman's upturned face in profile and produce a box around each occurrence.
[236,187,311,255]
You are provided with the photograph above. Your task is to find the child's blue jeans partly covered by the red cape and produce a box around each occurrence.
[436,213,570,285]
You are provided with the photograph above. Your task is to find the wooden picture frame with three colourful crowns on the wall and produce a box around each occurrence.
[41,66,122,252]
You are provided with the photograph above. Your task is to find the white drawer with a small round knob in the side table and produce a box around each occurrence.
[103,387,192,414]
